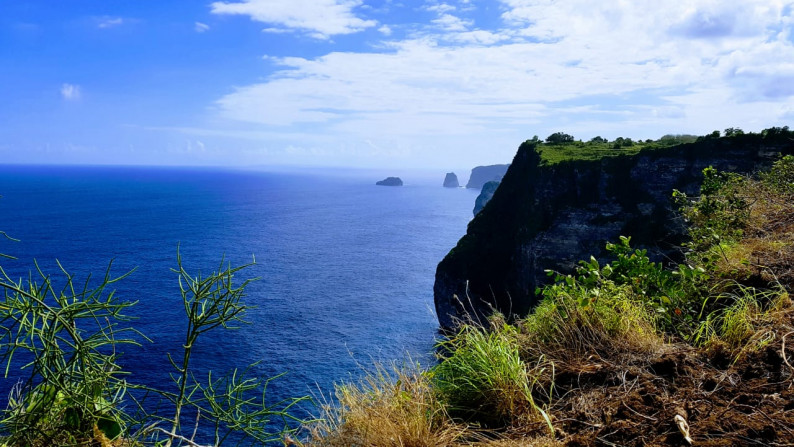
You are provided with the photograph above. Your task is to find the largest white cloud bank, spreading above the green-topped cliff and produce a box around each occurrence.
[207,0,794,166]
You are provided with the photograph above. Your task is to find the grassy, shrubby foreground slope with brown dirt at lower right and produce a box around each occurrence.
[308,156,794,447]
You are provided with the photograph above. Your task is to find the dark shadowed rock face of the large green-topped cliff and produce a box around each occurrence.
[434,134,794,328]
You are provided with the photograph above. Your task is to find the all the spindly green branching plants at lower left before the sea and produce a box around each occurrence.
[0,250,302,446]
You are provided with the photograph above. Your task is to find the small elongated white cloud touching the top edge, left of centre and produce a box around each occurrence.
[211,0,377,38]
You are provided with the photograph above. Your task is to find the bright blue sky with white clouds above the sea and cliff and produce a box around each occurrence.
[0,0,794,169]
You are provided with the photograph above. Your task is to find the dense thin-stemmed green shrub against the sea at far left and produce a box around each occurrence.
[0,267,136,445]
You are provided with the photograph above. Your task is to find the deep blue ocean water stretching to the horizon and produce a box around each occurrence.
[0,166,476,428]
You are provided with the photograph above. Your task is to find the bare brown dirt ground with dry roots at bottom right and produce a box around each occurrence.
[524,312,794,447]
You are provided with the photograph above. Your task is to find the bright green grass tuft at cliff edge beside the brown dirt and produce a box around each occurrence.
[430,326,551,426]
